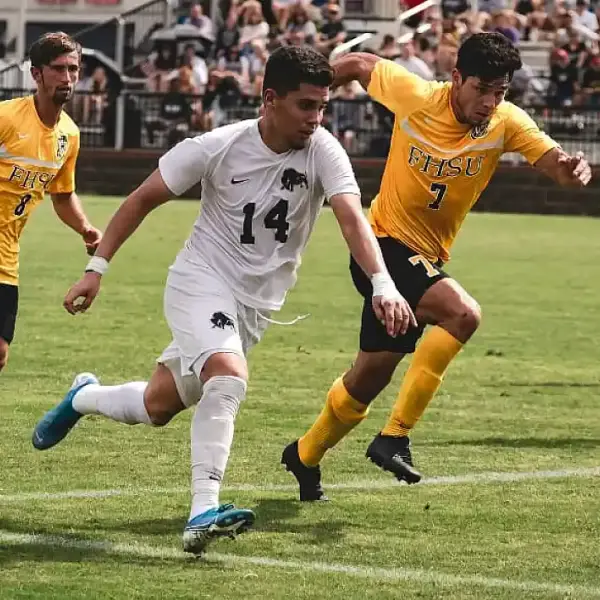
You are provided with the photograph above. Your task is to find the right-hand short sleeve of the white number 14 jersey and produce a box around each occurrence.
[315,129,360,201]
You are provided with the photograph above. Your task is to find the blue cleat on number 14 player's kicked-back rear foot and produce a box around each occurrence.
[31,373,99,450]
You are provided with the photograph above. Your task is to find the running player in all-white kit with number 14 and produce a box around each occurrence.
[33,47,416,554]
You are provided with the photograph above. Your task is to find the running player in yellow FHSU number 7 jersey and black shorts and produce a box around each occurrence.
[282,33,591,500]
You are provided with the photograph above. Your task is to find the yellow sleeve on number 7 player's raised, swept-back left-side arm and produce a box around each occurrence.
[367,59,436,116]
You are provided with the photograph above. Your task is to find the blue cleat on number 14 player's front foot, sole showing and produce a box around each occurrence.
[183,504,256,554]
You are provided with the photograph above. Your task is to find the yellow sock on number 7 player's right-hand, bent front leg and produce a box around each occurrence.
[381,327,463,436]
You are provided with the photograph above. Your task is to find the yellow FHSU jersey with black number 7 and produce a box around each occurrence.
[367,60,558,262]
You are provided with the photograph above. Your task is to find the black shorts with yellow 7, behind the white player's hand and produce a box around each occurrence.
[350,237,449,354]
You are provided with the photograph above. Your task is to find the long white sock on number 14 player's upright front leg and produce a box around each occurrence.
[190,376,246,519]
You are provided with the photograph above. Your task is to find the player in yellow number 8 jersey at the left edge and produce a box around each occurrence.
[0,33,101,370]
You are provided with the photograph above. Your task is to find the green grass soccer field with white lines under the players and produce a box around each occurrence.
[0,198,600,600]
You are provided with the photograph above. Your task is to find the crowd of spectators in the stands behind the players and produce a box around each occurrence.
[74,0,600,151]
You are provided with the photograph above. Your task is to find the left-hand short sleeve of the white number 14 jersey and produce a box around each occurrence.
[158,134,213,196]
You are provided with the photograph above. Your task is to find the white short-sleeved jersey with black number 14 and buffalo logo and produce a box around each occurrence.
[159,120,360,310]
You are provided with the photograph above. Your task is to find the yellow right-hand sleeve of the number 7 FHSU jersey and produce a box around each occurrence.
[504,102,558,165]
